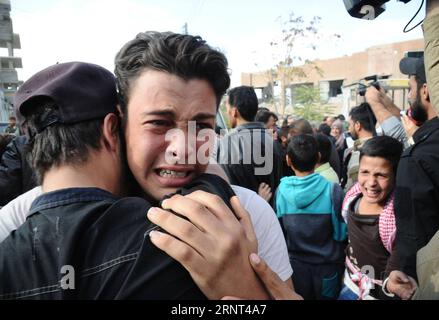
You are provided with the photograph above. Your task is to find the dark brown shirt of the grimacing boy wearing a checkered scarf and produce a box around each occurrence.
[346,195,398,298]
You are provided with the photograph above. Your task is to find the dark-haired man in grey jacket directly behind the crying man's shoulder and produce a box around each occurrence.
[217,86,282,204]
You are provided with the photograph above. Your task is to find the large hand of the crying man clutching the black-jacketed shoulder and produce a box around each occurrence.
[148,191,269,299]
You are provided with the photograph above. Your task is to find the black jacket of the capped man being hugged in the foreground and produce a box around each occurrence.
[0,175,234,300]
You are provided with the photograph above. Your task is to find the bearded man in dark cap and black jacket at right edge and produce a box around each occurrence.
[395,54,439,278]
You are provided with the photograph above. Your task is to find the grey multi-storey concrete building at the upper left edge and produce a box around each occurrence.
[0,0,23,122]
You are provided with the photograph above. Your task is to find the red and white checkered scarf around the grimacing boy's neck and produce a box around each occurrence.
[342,182,396,253]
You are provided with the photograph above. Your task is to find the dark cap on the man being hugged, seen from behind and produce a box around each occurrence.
[14,62,118,124]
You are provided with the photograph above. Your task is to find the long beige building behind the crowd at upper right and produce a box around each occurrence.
[241,39,424,115]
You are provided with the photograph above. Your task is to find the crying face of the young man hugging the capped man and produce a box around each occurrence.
[125,70,216,200]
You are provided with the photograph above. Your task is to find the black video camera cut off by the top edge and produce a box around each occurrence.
[343,0,411,20]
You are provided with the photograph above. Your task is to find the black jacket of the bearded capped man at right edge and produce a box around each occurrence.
[395,117,439,278]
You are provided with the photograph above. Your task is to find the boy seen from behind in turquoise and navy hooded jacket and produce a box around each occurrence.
[276,134,346,300]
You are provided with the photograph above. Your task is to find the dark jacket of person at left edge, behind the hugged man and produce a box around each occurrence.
[0,136,37,207]
